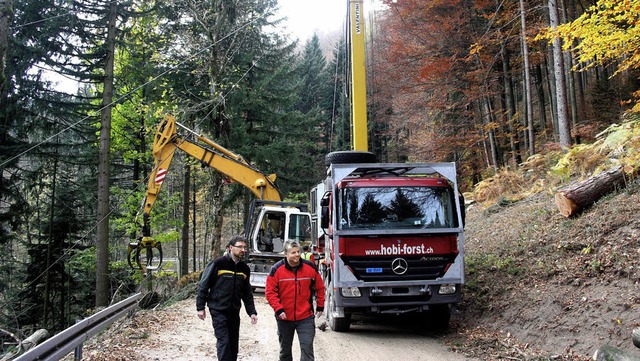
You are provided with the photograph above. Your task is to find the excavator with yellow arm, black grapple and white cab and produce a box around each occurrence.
[128,115,311,288]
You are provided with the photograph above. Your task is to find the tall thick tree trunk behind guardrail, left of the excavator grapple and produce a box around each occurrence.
[96,1,118,307]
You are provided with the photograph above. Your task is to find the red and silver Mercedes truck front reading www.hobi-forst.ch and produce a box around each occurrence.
[312,159,464,331]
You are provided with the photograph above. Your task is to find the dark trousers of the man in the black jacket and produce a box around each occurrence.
[209,309,240,361]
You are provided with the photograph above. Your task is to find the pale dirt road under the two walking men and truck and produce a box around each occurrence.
[79,292,471,361]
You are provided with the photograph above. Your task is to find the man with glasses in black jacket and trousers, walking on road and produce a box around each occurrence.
[196,236,258,361]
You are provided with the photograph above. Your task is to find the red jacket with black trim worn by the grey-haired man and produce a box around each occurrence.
[265,259,324,321]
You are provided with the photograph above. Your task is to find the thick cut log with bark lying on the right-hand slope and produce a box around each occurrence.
[555,166,625,218]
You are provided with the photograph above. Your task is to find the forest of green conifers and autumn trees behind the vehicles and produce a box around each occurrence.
[0,0,640,351]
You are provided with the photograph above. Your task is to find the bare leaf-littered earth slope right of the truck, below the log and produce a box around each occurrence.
[448,180,640,360]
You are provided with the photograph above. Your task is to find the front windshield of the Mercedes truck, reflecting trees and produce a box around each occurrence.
[338,187,458,229]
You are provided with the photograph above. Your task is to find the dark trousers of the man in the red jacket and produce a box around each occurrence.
[278,316,316,361]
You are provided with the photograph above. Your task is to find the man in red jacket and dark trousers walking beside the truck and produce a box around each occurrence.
[265,241,324,361]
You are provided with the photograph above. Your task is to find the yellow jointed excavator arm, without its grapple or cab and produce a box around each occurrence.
[142,115,282,236]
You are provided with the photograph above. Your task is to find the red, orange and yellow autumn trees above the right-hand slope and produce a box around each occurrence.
[369,0,640,184]
